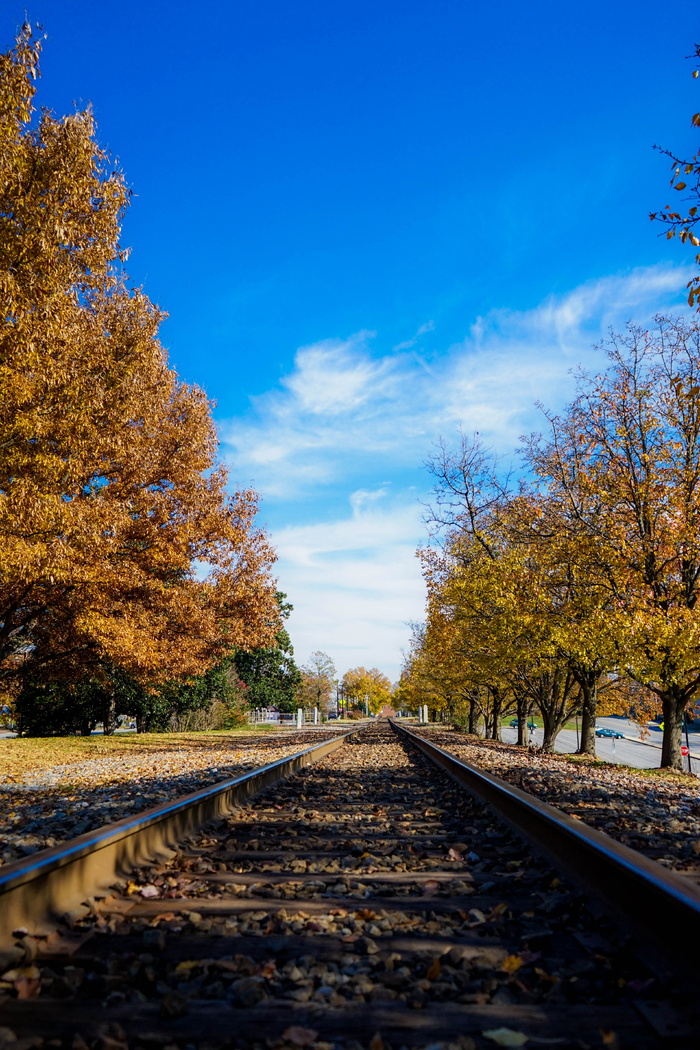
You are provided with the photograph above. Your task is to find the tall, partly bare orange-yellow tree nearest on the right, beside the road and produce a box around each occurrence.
[530,319,700,769]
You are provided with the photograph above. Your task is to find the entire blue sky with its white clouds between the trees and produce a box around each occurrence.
[15,0,700,678]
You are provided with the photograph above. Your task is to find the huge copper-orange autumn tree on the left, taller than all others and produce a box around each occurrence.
[0,25,277,684]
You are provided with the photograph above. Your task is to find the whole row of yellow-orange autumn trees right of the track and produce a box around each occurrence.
[401,318,700,769]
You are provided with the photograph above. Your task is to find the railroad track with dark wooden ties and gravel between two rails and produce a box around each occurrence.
[0,723,700,1050]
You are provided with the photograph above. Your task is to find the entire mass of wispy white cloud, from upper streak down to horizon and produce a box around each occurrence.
[220,258,687,677]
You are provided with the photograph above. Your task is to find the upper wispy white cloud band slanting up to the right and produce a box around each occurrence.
[220,260,685,500]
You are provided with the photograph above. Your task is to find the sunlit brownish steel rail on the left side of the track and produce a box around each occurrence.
[0,729,358,949]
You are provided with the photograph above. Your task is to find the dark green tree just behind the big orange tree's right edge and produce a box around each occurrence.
[233,591,302,711]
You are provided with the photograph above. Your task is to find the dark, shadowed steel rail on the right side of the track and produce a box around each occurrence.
[391,720,700,978]
